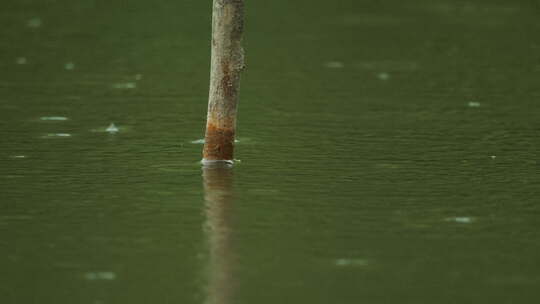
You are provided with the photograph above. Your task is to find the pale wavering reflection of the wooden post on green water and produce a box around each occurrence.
[203,163,234,304]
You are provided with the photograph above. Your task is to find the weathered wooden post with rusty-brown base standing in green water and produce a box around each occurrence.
[203,0,244,163]
